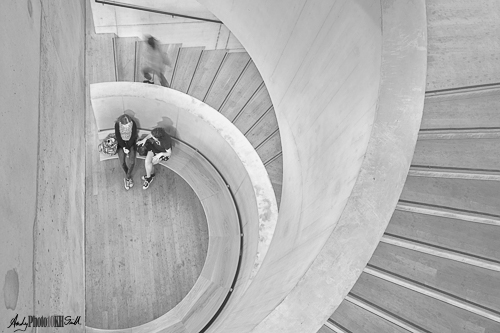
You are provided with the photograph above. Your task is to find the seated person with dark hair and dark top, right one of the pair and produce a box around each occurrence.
[137,127,172,190]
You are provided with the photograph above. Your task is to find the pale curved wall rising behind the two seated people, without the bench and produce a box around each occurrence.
[91,82,278,310]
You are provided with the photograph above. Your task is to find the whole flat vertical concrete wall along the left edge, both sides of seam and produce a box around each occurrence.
[0,0,85,332]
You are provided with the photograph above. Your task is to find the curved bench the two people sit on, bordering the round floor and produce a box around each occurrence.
[87,133,241,333]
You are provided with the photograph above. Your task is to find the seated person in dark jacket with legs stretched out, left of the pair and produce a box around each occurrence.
[115,114,137,190]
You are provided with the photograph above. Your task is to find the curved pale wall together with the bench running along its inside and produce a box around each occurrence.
[89,82,277,332]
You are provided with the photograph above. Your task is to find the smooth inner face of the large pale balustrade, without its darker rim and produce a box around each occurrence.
[195,1,381,326]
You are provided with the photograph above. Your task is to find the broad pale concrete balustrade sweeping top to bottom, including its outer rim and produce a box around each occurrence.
[195,0,426,332]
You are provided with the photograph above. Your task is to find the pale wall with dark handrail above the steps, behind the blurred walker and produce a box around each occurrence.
[90,0,244,51]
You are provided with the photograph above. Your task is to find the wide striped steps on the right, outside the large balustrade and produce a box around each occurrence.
[324,0,500,333]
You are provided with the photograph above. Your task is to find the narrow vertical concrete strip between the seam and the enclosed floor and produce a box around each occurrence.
[33,0,85,331]
